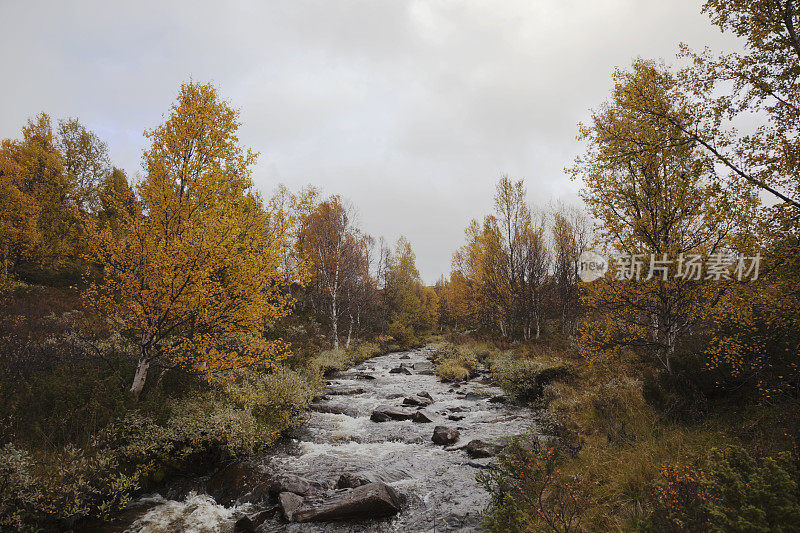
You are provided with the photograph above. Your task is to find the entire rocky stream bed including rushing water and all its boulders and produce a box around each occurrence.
[84,349,532,533]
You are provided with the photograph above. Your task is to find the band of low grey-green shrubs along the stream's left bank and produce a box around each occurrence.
[0,366,319,529]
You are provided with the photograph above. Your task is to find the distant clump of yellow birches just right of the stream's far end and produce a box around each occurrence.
[436,176,590,341]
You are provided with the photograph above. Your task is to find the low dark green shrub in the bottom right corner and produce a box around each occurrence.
[644,446,800,532]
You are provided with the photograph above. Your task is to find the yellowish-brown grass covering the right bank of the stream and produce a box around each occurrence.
[456,342,800,531]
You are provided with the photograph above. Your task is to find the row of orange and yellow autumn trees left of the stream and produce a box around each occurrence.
[0,83,438,395]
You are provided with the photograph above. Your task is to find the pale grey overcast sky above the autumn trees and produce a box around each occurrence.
[0,0,737,283]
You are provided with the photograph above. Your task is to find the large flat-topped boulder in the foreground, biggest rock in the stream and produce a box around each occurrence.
[292,481,400,522]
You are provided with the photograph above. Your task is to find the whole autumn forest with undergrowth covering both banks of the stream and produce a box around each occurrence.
[0,0,800,532]
